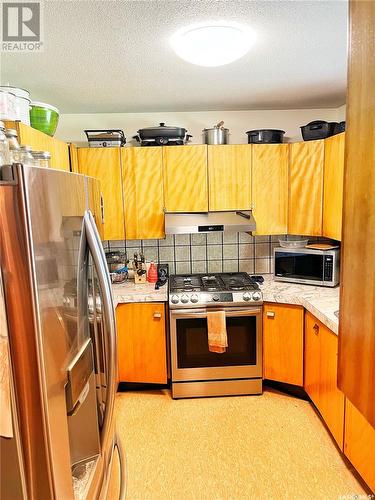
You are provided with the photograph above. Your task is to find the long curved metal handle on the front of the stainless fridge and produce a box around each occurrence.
[84,210,117,447]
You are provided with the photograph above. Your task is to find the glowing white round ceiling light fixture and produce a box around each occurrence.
[170,21,255,67]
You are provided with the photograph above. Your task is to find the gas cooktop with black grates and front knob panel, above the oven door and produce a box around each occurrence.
[169,273,262,307]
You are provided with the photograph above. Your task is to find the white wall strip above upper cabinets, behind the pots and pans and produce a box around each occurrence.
[56,106,345,146]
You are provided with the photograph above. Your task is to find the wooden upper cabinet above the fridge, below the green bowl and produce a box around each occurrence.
[5,121,70,172]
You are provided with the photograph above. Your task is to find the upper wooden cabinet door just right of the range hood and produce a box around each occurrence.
[252,144,289,234]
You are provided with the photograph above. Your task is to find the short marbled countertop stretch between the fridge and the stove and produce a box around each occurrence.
[112,280,168,307]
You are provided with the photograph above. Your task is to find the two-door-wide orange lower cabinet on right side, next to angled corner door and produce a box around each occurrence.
[304,312,344,449]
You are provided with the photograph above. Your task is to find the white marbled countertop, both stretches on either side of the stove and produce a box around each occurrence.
[112,276,340,335]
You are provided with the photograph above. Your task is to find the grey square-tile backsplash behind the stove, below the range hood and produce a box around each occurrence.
[103,233,285,274]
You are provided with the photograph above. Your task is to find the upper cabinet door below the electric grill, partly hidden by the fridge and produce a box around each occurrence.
[78,148,125,240]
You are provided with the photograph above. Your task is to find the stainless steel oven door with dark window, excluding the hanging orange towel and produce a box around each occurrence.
[170,307,262,381]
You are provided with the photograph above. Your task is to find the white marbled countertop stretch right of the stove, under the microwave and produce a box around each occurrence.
[260,276,340,335]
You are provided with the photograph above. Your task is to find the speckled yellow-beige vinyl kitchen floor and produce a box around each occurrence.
[113,390,367,500]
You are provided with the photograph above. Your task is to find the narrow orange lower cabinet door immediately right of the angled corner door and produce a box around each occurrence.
[304,313,320,407]
